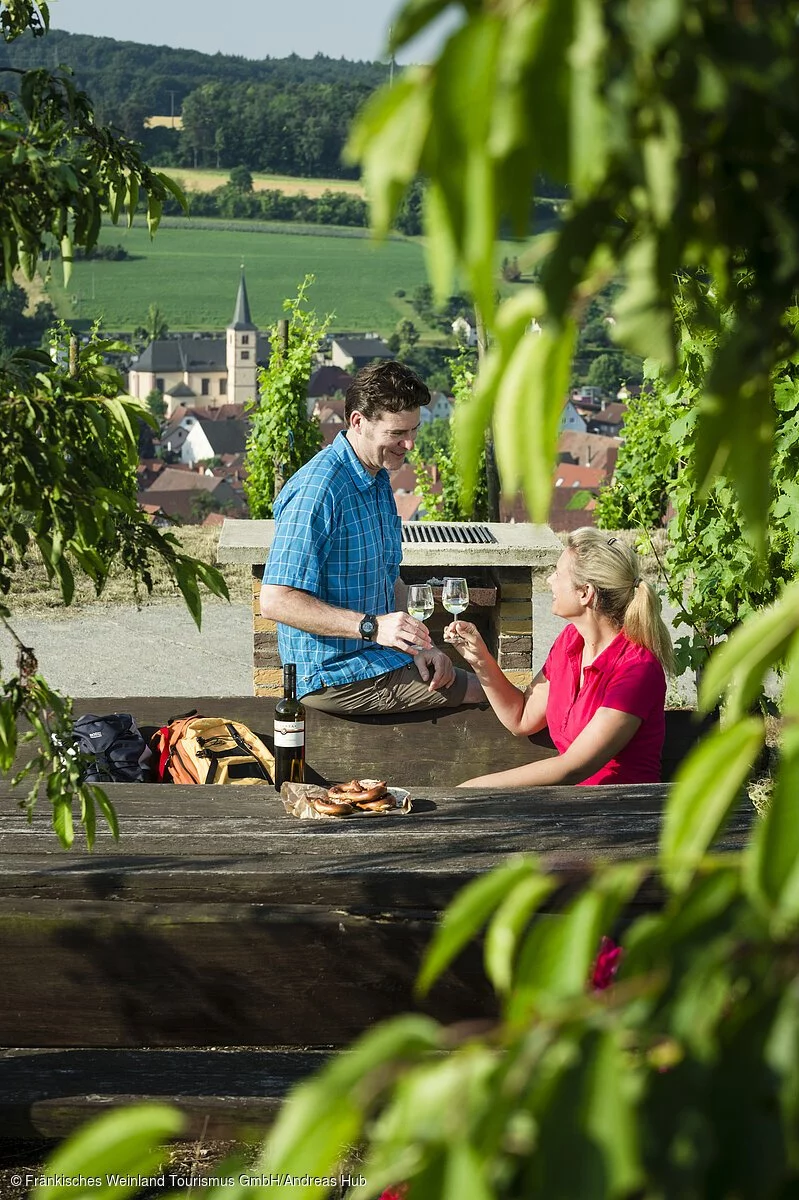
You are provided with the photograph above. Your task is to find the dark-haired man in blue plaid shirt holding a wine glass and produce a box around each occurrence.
[260,362,485,713]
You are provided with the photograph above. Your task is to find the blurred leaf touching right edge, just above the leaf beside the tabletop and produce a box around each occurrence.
[699,583,799,719]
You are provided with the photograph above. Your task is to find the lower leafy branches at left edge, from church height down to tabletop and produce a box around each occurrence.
[0,341,228,846]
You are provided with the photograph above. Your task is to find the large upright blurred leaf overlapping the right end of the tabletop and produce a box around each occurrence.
[660,718,763,892]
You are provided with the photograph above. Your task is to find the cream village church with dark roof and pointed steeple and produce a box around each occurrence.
[128,270,269,419]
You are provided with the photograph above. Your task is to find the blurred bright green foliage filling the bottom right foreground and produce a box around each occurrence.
[36,592,799,1200]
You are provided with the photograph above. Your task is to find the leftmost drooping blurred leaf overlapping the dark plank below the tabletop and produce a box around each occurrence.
[416,858,537,995]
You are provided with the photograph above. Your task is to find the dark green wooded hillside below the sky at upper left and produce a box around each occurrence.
[0,30,389,178]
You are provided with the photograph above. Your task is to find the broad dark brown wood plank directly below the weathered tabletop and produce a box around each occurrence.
[0,899,495,1046]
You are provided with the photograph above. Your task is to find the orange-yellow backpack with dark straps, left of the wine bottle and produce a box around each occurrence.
[150,713,275,784]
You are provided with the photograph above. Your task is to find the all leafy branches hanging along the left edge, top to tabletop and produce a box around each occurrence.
[0,0,227,846]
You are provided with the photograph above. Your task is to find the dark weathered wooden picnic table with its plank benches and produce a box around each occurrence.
[0,698,751,1136]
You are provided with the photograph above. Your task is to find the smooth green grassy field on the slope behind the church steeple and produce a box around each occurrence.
[48,220,426,332]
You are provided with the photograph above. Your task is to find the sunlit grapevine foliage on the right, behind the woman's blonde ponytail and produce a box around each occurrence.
[596,287,799,671]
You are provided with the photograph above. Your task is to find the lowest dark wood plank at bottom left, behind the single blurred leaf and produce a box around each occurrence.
[0,1046,329,1138]
